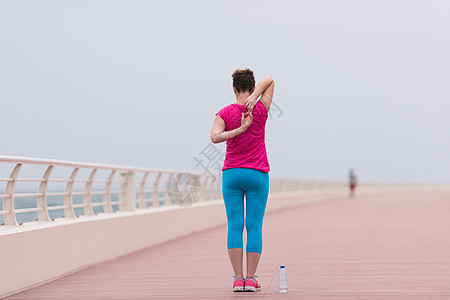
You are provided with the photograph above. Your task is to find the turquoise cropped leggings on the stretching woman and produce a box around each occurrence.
[222,168,269,253]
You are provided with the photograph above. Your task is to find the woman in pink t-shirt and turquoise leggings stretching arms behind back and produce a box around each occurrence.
[211,69,274,292]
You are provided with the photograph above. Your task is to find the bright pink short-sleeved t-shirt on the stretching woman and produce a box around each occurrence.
[217,102,270,172]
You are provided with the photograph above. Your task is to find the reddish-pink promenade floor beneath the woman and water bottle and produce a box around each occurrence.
[8,190,450,299]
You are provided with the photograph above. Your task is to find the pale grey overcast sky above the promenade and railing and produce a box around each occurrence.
[0,0,450,182]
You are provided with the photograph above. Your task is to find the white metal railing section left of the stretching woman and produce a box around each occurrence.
[0,156,211,225]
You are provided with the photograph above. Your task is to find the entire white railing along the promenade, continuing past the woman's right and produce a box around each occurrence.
[0,156,342,225]
